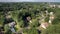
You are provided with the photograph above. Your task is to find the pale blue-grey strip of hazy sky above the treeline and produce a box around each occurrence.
[0,0,60,2]
